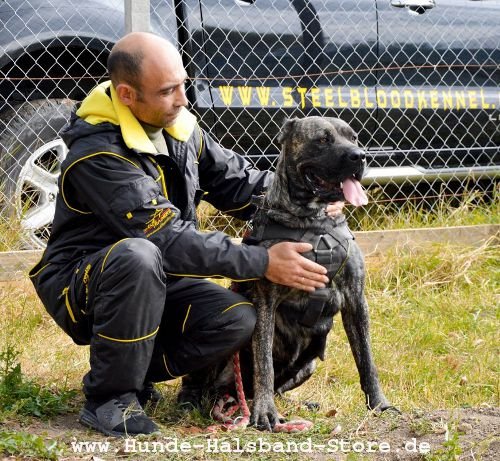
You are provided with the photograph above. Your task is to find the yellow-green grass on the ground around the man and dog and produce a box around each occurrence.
[0,235,500,461]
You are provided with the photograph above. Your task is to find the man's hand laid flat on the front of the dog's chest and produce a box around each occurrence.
[264,242,328,292]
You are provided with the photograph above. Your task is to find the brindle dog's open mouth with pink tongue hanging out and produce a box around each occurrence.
[304,171,368,206]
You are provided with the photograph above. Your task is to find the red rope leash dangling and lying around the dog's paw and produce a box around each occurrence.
[207,352,313,433]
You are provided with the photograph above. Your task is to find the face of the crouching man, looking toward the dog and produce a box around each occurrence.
[128,52,188,128]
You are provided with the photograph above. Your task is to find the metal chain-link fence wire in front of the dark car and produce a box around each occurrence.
[0,0,500,250]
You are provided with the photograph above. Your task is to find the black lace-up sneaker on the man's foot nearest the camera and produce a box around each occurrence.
[79,392,159,437]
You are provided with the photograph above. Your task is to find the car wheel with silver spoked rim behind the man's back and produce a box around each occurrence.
[0,99,73,248]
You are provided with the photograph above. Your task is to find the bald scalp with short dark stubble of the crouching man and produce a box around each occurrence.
[108,32,182,91]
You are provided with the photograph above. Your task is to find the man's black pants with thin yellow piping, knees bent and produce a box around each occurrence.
[35,238,256,398]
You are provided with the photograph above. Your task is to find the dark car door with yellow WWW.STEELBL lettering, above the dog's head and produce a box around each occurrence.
[196,0,377,168]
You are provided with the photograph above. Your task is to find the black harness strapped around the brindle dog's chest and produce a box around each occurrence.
[243,216,354,327]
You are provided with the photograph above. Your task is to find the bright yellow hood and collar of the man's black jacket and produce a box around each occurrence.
[76,81,196,154]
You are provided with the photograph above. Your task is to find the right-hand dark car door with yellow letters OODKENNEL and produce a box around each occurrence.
[372,0,500,183]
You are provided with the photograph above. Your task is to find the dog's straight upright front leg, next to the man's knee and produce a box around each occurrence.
[250,281,279,431]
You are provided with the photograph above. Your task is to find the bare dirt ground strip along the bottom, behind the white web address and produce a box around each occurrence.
[0,407,500,461]
